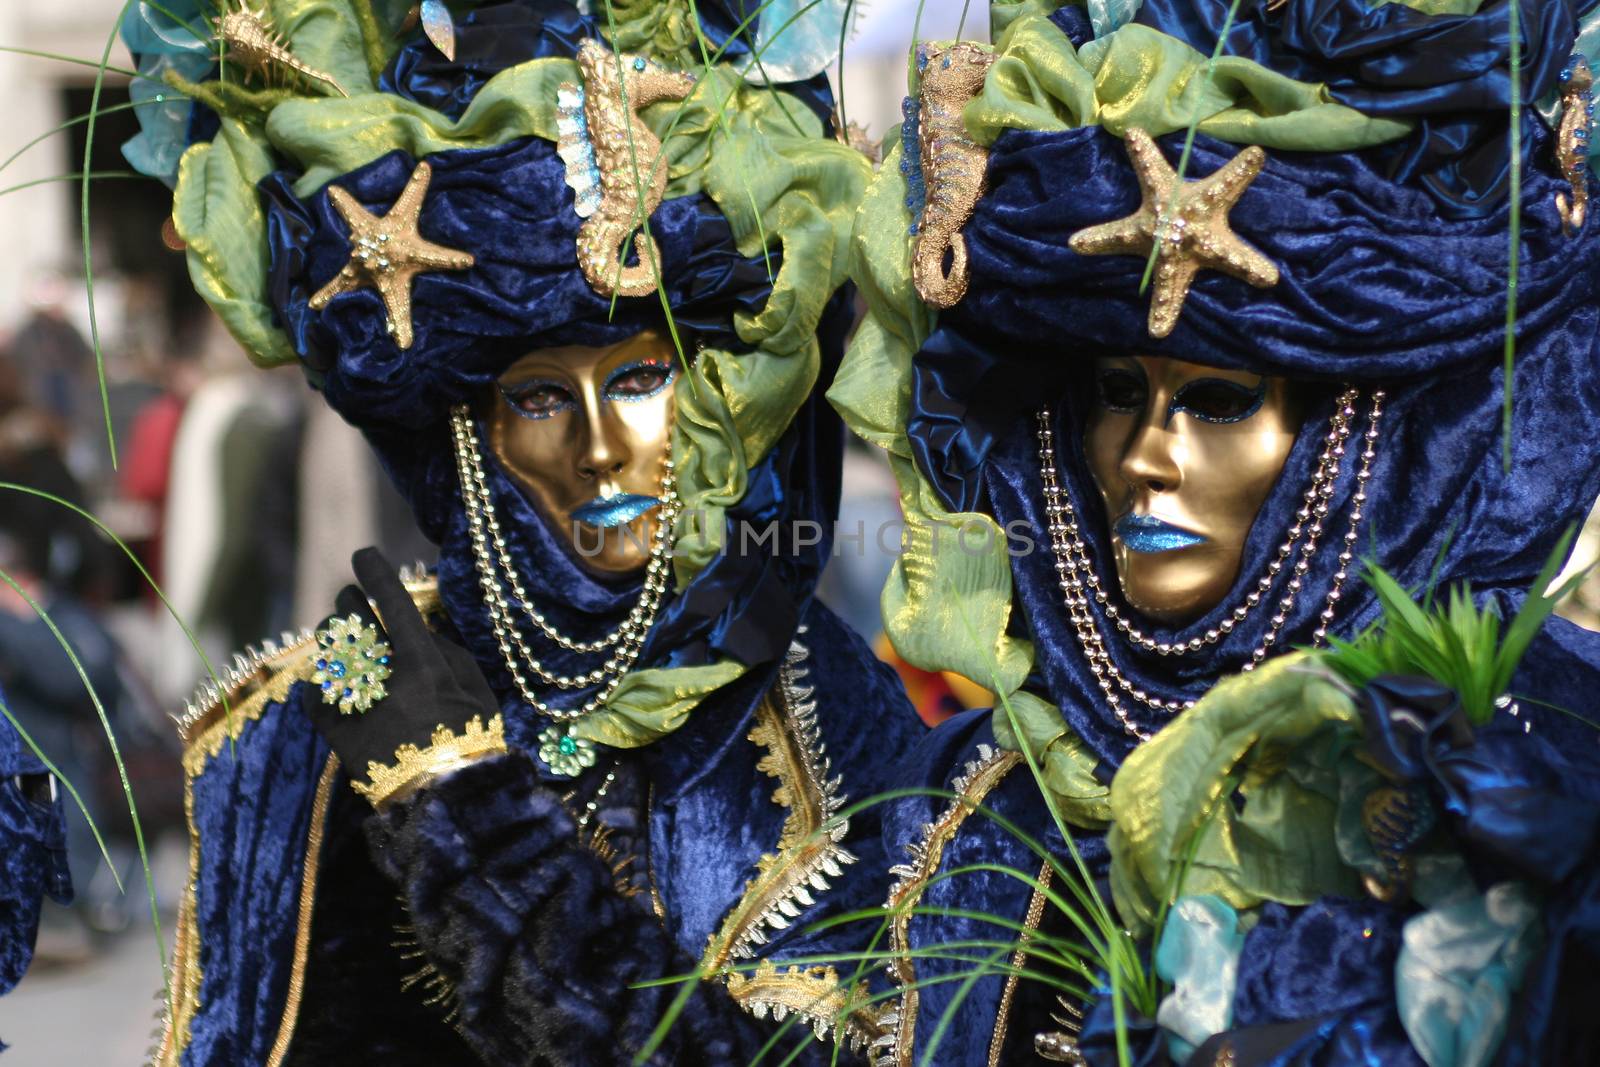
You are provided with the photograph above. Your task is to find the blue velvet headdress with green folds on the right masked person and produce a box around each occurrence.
[834,0,1600,774]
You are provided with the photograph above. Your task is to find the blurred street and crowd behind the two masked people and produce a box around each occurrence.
[0,0,1600,1067]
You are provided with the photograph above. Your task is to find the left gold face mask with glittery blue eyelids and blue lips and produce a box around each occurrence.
[483,331,677,574]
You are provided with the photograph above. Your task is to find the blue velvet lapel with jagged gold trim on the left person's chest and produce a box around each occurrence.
[648,603,923,1046]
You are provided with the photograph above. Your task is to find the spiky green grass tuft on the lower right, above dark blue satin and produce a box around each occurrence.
[1326,528,1592,725]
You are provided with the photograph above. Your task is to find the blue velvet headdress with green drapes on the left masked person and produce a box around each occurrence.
[130,0,866,744]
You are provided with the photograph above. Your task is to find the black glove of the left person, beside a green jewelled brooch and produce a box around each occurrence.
[307,549,499,793]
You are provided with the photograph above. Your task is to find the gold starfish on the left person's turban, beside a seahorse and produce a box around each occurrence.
[310,163,475,349]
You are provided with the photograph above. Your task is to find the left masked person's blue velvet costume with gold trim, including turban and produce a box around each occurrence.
[136,0,922,1067]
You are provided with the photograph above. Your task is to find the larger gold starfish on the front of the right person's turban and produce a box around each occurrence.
[1069,130,1278,338]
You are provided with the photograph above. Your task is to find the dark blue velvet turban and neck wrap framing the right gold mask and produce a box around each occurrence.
[909,73,1600,766]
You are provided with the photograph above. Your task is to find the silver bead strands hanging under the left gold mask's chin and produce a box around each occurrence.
[450,405,680,721]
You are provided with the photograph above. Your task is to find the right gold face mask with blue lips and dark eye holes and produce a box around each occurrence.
[1085,355,1304,625]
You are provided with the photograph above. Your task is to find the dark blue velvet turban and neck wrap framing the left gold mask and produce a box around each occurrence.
[252,10,848,758]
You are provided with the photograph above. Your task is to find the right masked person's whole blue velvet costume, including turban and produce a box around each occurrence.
[846,0,1600,1065]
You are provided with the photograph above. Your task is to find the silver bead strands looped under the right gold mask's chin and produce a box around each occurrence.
[1037,389,1384,741]
